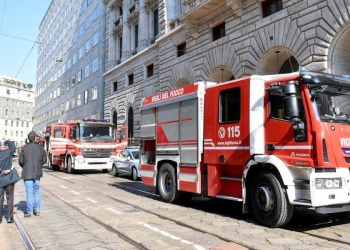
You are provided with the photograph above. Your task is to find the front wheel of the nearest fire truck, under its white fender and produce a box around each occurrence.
[251,171,293,227]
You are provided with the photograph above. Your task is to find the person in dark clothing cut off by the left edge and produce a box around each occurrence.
[0,138,16,224]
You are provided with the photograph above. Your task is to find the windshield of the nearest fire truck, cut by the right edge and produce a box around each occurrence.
[311,85,350,123]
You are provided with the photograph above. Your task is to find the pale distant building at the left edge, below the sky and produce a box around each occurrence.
[0,75,35,145]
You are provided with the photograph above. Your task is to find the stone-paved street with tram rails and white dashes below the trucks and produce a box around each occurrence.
[0,161,350,249]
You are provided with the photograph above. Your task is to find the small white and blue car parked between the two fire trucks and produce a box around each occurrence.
[112,148,141,181]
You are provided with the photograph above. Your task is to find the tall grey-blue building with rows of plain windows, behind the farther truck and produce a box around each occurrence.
[34,0,106,131]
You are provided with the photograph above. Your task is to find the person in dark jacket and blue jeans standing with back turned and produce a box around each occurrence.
[18,131,47,217]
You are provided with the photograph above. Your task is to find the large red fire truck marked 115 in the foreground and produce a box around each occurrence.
[140,71,350,227]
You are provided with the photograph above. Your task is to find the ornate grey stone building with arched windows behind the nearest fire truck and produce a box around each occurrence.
[104,0,350,144]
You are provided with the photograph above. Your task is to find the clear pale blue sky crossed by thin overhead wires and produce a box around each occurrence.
[0,0,51,86]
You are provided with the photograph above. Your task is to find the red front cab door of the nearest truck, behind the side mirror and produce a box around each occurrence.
[264,81,313,167]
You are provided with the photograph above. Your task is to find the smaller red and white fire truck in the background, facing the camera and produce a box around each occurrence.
[44,119,127,173]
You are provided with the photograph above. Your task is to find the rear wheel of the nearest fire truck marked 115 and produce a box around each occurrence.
[157,163,181,203]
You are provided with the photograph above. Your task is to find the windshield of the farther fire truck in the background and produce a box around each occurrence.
[77,123,116,142]
